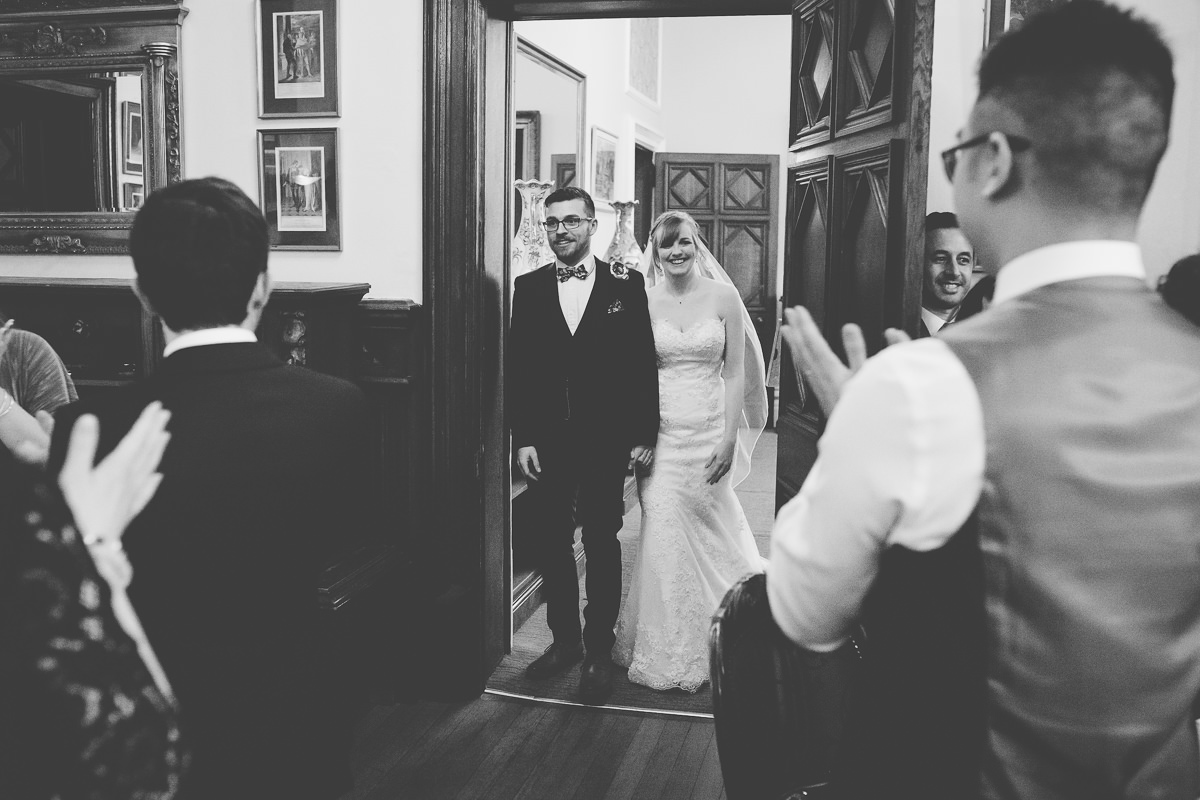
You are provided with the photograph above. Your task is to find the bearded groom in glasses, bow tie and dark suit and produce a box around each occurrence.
[506,187,659,704]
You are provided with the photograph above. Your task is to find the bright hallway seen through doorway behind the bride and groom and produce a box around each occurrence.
[487,16,792,715]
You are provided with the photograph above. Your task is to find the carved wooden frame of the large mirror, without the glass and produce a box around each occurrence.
[0,0,187,255]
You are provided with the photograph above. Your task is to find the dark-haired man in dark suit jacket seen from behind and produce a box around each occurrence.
[52,178,370,800]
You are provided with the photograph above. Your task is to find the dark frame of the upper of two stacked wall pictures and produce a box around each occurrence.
[254,0,342,120]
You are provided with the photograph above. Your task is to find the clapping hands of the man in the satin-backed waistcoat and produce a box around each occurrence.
[780,306,908,416]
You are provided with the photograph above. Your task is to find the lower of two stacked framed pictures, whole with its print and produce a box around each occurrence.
[258,128,342,249]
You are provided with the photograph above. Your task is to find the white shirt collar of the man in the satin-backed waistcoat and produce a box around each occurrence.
[991,239,1146,303]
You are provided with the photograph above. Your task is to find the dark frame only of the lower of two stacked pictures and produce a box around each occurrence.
[257,127,342,251]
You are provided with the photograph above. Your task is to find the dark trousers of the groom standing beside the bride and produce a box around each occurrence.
[529,420,630,657]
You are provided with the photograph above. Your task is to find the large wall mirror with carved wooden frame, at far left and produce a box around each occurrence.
[0,0,187,254]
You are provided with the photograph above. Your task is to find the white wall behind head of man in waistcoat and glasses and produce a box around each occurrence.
[929,0,1200,283]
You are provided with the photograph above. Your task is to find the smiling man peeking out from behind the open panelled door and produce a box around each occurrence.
[920,211,974,337]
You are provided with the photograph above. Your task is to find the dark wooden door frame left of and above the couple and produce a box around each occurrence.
[422,0,916,697]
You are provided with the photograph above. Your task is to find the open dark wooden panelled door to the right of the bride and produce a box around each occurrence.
[775,0,934,507]
